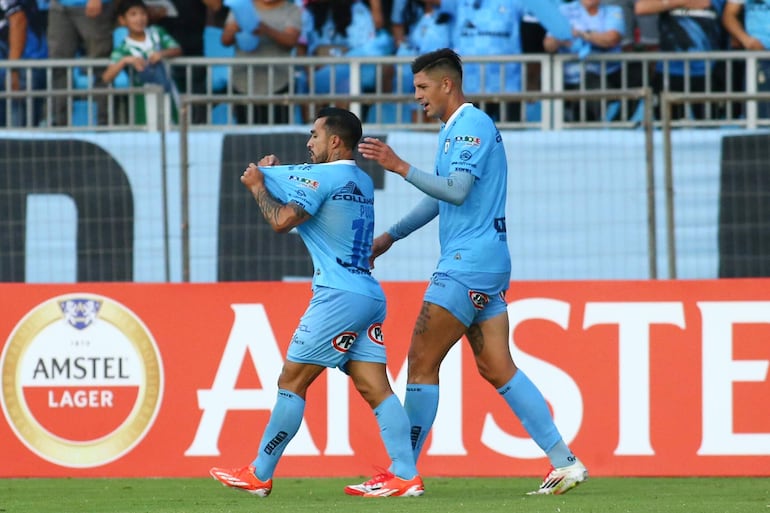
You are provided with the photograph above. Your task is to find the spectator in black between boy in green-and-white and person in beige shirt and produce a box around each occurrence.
[150,0,222,123]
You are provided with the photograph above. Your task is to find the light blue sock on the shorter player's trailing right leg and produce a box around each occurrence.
[374,395,417,479]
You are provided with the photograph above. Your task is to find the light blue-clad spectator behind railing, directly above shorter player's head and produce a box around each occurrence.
[299,0,394,103]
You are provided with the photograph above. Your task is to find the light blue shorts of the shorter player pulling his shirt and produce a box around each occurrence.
[286,287,387,371]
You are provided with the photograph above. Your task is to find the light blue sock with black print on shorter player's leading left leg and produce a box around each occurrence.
[252,390,305,481]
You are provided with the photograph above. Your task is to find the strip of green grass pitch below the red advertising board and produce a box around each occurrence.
[0,477,770,513]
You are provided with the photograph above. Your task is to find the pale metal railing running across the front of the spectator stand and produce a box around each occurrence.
[0,52,770,130]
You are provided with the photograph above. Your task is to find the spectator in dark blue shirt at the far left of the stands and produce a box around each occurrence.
[0,0,48,126]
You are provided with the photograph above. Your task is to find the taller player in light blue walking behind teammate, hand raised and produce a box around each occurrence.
[352,48,588,495]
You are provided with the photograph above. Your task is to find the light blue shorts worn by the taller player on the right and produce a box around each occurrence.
[423,271,511,327]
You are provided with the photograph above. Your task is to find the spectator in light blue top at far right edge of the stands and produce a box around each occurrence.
[722,0,770,118]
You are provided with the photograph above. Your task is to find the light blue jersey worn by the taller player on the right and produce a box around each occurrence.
[435,103,511,274]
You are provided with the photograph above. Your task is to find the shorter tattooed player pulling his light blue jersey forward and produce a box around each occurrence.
[210,107,424,497]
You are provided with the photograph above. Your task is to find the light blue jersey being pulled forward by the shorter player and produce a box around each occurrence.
[260,160,385,300]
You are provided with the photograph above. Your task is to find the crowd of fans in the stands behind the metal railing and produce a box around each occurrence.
[0,0,770,126]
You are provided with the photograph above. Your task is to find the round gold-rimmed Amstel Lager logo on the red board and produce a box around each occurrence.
[0,294,163,468]
